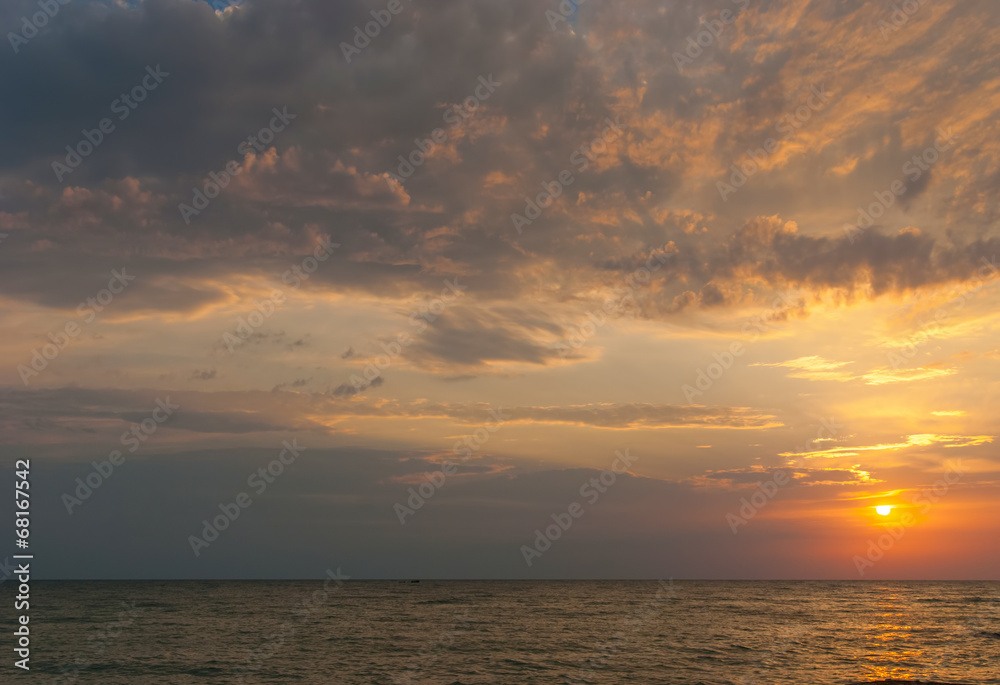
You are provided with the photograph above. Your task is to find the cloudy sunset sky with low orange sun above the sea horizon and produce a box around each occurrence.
[0,0,1000,580]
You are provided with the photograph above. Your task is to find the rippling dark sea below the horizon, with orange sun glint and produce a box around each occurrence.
[7,581,1000,685]
